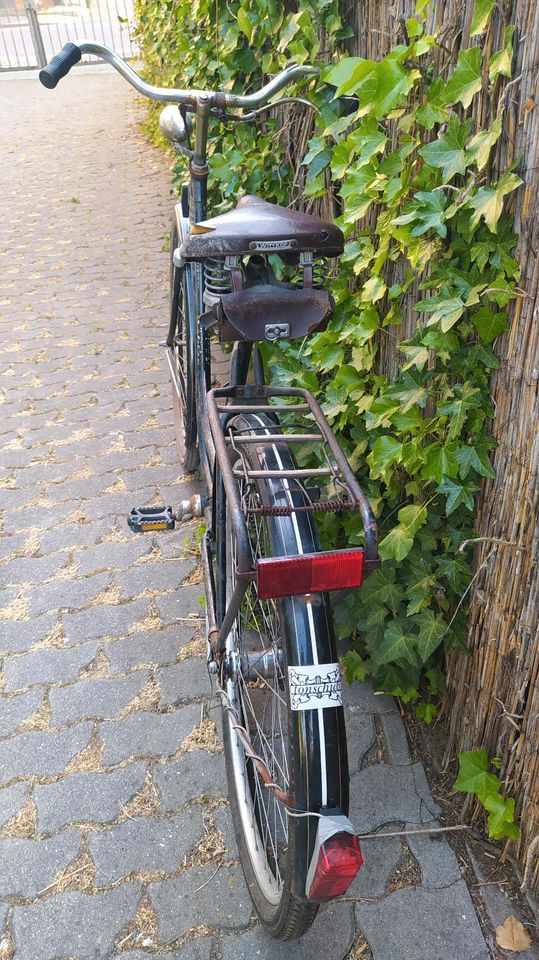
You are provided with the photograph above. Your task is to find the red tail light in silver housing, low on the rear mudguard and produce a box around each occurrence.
[305,816,363,902]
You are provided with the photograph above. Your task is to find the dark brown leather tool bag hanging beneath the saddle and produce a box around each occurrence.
[202,284,334,343]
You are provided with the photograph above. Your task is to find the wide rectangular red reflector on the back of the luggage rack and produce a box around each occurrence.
[256,547,363,600]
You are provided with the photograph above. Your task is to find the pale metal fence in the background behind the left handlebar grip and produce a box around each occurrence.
[0,0,137,70]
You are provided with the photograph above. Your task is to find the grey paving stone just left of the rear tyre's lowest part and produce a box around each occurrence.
[149,863,254,943]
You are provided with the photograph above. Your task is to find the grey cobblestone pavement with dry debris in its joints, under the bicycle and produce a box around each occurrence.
[0,69,489,960]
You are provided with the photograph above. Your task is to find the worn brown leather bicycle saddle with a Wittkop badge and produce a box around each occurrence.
[180,196,344,260]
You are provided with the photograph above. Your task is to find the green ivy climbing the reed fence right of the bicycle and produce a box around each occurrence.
[137,0,521,722]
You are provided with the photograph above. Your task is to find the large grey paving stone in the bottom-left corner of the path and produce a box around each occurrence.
[13,883,140,960]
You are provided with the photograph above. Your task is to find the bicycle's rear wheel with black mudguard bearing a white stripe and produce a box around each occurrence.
[217,414,348,940]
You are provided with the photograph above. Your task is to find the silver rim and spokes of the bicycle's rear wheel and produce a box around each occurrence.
[226,491,291,906]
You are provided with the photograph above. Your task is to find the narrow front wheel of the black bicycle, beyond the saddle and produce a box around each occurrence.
[170,219,199,473]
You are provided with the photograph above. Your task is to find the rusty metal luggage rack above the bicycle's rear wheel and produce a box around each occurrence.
[206,385,380,654]
